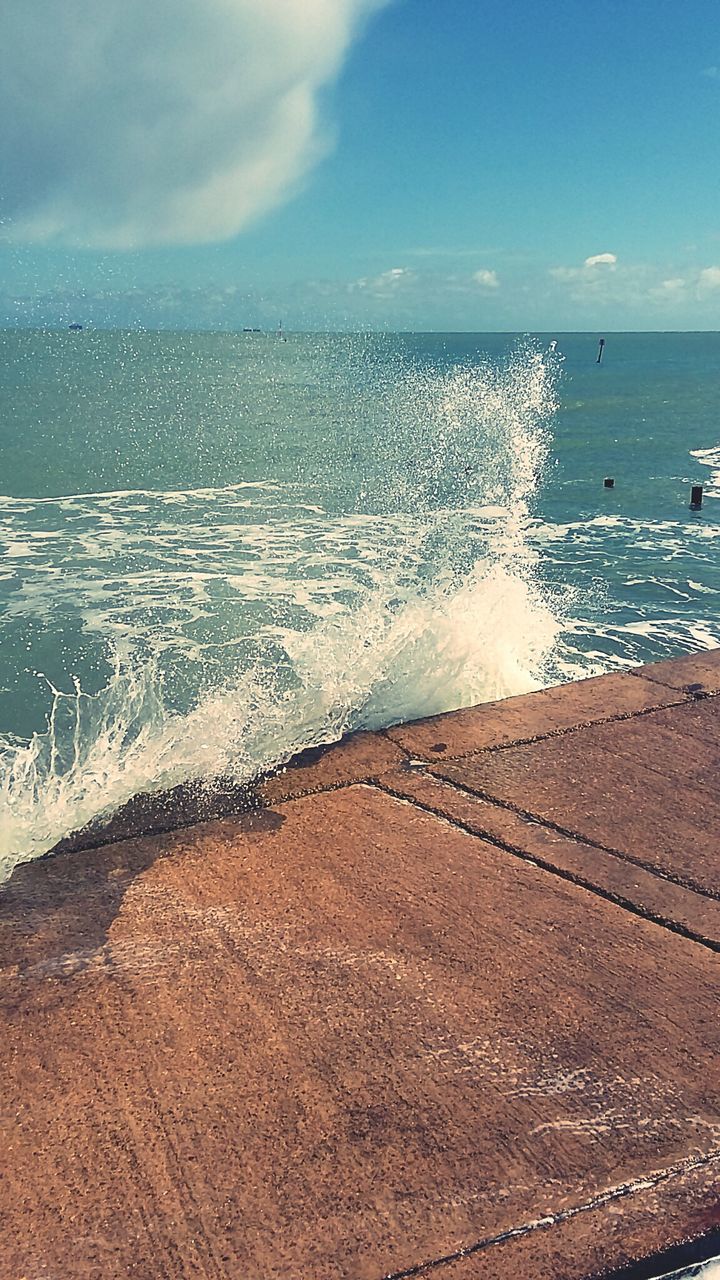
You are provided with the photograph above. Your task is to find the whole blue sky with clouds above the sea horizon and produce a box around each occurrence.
[0,0,720,332]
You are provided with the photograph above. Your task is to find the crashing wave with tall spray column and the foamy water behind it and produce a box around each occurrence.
[0,344,559,877]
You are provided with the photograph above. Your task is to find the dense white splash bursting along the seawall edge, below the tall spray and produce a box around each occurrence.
[0,555,557,876]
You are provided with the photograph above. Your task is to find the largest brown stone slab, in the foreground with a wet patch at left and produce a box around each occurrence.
[0,783,720,1280]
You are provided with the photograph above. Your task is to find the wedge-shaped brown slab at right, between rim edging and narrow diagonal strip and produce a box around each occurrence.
[433,699,720,895]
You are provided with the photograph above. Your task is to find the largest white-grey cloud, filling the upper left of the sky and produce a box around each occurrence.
[0,0,387,248]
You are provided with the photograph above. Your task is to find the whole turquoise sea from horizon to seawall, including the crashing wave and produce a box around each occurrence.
[0,330,720,874]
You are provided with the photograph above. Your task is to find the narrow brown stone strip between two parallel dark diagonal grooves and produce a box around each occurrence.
[382,769,720,948]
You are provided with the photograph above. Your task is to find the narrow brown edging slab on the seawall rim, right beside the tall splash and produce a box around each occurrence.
[386,673,683,760]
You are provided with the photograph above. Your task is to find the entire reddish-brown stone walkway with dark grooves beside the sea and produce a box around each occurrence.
[0,650,720,1280]
